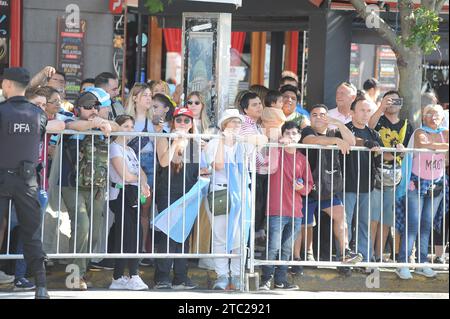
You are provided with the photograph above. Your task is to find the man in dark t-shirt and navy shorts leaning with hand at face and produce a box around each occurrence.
[294,104,362,263]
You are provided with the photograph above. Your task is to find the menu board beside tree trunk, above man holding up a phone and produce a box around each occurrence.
[377,45,398,93]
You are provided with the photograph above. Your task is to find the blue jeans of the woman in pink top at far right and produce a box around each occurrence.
[398,189,444,263]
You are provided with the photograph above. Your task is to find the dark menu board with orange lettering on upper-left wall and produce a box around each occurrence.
[56,17,86,102]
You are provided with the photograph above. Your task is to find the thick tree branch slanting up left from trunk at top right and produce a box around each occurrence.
[350,0,405,55]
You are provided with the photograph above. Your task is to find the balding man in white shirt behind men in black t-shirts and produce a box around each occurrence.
[328,82,357,128]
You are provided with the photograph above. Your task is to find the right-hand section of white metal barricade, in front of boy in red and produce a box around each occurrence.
[249,144,448,288]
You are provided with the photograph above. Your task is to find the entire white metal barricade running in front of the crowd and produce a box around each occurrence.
[0,131,448,290]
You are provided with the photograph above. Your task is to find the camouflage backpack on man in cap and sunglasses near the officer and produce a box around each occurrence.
[67,135,109,189]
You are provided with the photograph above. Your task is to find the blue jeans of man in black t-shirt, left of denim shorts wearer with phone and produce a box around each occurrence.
[345,193,373,261]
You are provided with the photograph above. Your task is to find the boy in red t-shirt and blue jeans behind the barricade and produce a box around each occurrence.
[259,121,314,290]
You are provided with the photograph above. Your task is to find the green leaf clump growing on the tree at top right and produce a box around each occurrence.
[400,7,440,54]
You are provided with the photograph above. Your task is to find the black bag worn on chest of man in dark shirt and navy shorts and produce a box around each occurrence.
[311,132,343,200]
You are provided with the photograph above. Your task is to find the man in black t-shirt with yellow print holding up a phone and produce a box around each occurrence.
[369,91,414,261]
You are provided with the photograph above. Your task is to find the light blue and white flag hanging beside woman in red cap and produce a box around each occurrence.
[152,177,209,243]
